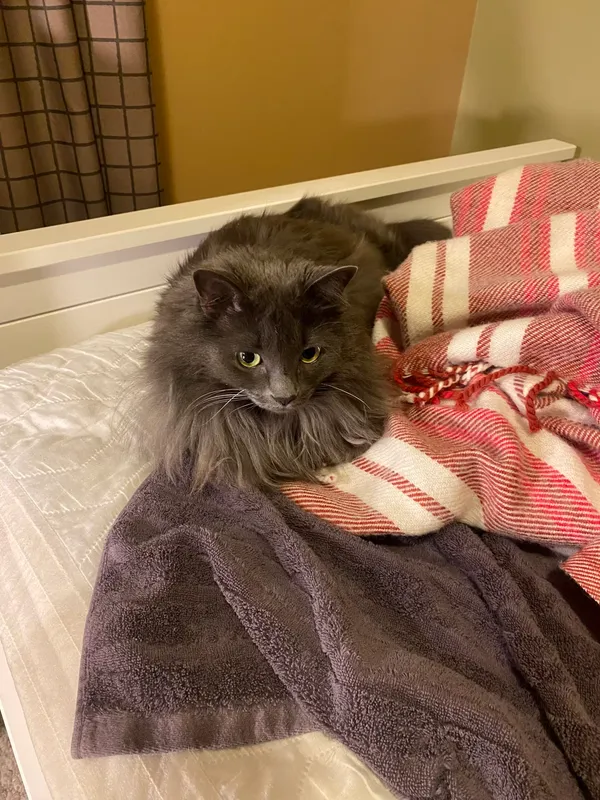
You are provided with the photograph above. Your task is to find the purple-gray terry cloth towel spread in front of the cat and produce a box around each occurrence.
[73,473,600,800]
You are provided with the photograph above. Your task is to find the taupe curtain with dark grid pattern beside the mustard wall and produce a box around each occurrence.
[0,0,161,233]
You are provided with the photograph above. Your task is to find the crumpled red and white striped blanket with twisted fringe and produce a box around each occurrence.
[285,161,600,601]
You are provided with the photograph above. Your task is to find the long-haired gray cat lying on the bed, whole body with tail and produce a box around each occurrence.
[144,198,450,487]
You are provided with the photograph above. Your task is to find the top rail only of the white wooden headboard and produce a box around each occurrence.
[0,139,576,275]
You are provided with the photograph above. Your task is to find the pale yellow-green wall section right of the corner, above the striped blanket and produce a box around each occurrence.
[453,0,600,158]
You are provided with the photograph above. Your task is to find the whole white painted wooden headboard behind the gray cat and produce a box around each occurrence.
[0,139,576,367]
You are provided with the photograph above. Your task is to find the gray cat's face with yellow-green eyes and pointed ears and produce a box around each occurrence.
[194,267,356,414]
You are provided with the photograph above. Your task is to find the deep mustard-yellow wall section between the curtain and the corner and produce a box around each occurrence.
[146,0,476,202]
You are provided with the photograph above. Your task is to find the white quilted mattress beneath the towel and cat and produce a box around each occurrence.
[0,326,391,800]
